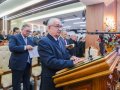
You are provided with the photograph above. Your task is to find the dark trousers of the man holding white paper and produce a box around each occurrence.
[12,63,31,90]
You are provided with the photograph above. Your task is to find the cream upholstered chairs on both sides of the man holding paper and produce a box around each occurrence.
[0,46,41,90]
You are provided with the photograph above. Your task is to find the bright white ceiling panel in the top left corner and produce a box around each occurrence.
[0,0,45,17]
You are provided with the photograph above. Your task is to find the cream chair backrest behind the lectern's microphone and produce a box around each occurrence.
[85,47,99,59]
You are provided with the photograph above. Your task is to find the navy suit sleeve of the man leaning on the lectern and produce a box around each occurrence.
[38,40,73,70]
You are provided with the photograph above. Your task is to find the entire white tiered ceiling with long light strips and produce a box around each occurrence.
[0,0,105,32]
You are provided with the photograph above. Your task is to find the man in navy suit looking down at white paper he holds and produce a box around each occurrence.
[9,24,34,90]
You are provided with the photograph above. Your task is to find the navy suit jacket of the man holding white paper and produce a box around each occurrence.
[9,34,34,70]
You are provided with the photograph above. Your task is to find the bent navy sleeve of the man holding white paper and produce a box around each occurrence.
[9,36,25,53]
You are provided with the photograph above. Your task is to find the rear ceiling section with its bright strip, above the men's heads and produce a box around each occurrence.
[14,2,86,31]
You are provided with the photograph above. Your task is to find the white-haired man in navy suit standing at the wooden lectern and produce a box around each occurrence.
[38,18,83,90]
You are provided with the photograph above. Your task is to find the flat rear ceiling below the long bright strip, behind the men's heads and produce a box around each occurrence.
[29,11,86,30]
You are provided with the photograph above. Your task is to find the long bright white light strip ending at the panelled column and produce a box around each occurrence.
[23,6,86,22]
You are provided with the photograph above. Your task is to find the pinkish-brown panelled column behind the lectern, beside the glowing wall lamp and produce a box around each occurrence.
[86,0,116,49]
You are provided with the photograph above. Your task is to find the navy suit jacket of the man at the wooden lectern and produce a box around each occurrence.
[38,34,73,77]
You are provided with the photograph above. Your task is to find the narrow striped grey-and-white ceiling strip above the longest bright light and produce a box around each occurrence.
[8,0,73,20]
